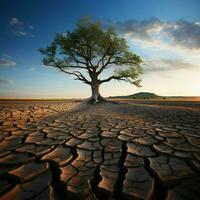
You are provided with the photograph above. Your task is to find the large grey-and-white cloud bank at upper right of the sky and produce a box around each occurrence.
[111,18,200,51]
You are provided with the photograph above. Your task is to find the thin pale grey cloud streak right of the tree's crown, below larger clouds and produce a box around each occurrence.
[142,58,197,73]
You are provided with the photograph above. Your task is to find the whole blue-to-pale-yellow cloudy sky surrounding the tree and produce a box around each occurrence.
[0,0,200,98]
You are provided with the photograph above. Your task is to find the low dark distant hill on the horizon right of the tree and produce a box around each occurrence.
[109,92,162,99]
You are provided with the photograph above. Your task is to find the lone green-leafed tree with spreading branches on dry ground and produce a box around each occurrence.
[40,18,142,103]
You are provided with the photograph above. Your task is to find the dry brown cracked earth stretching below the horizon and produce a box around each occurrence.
[0,101,200,200]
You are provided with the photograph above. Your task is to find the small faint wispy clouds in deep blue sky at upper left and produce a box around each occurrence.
[9,17,35,37]
